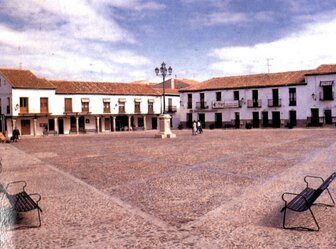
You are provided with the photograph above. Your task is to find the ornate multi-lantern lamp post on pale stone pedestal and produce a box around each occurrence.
[154,62,176,138]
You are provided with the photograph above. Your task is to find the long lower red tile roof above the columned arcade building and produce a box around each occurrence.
[50,80,160,96]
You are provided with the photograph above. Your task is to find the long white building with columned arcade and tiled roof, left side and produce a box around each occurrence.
[0,69,173,137]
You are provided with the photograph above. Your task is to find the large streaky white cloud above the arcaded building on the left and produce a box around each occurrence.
[0,0,163,81]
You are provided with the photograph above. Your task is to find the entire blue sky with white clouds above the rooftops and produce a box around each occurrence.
[0,0,336,82]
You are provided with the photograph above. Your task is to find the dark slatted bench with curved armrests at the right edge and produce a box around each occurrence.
[281,172,336,231]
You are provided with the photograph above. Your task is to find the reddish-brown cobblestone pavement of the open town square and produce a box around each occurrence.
[0,129,336,248]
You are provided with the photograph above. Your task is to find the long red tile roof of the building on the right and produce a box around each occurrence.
[180,65,336,92]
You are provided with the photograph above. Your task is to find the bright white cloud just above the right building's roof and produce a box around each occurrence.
[209,16,336,75]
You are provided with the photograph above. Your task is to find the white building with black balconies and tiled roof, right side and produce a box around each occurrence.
[180,65,336,128]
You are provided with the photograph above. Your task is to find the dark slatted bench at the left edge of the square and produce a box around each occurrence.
[0,181,42,227]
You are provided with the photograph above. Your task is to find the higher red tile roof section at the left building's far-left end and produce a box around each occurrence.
[0,68,55,89]
